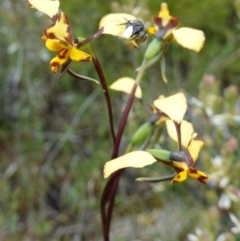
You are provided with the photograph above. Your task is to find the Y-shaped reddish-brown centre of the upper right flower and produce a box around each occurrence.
[152,16,179,40]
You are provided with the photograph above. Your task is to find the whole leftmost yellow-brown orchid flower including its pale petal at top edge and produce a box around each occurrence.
[27,0,92,73]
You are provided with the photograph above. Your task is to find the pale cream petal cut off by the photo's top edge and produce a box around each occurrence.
[27,0,60,18]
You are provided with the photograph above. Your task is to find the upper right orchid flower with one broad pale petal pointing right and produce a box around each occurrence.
[147,3,205,52]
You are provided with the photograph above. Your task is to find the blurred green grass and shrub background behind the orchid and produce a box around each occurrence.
[0,0,240,241]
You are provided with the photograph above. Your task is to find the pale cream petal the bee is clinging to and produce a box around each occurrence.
[99,13,136,37]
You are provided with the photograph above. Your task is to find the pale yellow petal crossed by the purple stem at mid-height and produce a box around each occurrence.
[109,77,142,99]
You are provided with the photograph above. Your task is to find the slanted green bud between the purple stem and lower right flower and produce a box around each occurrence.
[131,122,153,146]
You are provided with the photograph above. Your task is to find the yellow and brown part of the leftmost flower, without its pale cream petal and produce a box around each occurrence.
[42,12,92,73]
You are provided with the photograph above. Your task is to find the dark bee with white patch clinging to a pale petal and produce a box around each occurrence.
[123,19,148,47]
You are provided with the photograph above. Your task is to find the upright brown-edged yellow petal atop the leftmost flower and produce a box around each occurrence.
[44,12,74,46]
